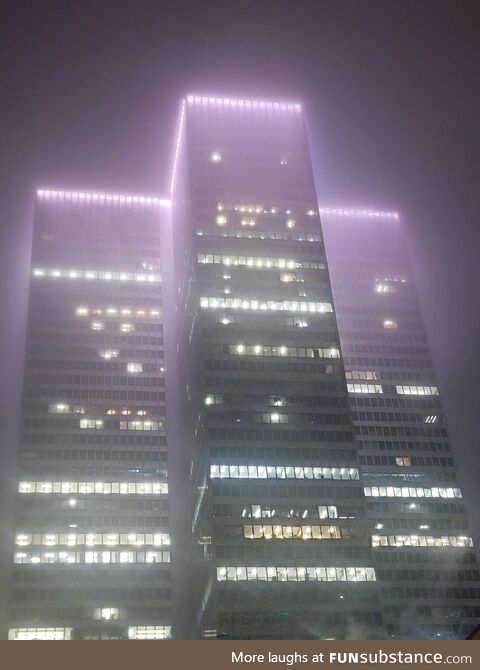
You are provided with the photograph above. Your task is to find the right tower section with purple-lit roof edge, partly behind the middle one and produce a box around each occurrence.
[322,208,480,638]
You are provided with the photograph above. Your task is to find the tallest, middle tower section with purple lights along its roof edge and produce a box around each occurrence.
[172,96,384,638]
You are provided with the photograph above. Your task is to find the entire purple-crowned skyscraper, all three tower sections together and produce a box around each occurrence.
[9,95,480,640]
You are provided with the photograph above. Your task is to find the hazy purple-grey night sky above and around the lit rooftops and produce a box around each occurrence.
[0,0,480,636]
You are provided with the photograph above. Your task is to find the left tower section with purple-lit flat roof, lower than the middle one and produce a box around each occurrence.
[9,190,172,640]
